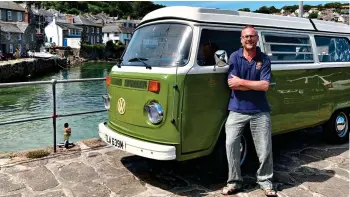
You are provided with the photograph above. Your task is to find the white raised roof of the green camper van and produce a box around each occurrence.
[140,6,350,33]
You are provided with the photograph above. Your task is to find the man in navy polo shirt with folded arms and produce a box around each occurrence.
[222,26,277,196]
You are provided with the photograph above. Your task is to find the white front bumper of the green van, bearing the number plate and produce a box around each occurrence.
[98,123,176,160]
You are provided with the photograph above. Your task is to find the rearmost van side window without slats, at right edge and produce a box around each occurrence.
[315,36,350,62]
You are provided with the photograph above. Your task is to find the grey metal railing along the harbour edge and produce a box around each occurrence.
[0,78,107,152]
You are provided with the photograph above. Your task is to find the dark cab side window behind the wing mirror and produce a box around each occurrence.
[197,29,242,66]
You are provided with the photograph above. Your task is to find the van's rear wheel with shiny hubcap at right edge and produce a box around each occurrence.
[323,110,349,144]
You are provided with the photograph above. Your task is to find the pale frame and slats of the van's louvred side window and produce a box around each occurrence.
[260,30,318,64]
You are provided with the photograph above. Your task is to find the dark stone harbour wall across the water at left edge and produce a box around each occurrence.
[0,59,67,83]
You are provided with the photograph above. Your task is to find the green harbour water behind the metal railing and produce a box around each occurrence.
[0,63,113,153]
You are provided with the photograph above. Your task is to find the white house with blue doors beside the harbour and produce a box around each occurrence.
[45,17,83,48]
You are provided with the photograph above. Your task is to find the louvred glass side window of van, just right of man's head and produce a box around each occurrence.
[263,33,314,63]
